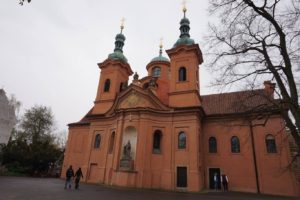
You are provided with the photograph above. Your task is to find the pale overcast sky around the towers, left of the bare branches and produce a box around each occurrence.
[0,0,213,130]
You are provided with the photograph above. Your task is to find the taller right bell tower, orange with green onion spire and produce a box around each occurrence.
[166,6,203,107]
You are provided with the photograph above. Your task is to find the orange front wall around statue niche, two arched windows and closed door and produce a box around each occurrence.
[99,113,203,191]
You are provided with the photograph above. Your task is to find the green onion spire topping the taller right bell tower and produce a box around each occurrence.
[174,1,195,47]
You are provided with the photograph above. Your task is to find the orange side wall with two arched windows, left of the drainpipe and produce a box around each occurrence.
[203,119,262,192]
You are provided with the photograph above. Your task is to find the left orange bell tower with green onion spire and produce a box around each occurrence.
[92,19,133,114]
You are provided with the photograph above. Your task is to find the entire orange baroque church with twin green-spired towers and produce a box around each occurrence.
[62,6,300,196]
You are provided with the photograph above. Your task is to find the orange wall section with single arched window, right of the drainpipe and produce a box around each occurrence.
[253,116,300,196]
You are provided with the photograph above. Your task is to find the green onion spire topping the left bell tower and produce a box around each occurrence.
[108,18,127,63]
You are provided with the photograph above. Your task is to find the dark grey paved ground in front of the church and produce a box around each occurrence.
[0,177,299,200]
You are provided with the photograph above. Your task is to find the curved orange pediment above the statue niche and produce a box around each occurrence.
[107,86,170,114]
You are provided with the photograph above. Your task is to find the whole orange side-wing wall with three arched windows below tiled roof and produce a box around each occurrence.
[203,118,299,196]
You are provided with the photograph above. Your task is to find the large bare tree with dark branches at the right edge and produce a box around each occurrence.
[206,0,300,155]
